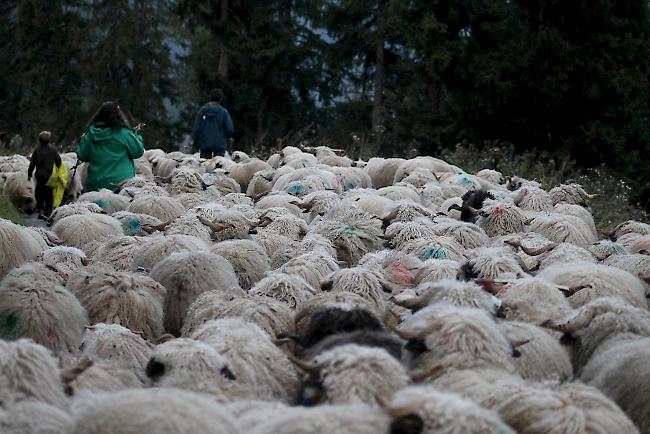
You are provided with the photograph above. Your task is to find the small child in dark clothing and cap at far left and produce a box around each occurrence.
[27,131,61,217]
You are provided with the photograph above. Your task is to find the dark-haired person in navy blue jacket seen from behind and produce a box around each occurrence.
[192,89,235,159]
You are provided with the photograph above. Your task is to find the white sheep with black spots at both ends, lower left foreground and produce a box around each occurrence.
[145,338,246,402]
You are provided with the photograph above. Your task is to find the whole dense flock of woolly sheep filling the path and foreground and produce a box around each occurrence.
[0,147,650,434]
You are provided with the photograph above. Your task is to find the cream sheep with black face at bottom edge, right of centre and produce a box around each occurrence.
[383,386,514,434]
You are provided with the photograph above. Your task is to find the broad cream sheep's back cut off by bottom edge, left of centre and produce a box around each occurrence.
[71,388,239,434]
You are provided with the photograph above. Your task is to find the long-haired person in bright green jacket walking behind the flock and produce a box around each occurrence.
[77,101,144,192]
